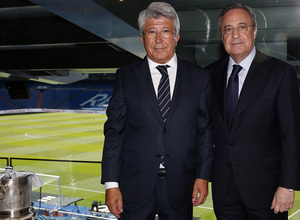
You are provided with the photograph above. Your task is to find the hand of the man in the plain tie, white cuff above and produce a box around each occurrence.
[271,186,295,214]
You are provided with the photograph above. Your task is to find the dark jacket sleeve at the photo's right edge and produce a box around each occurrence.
[277,65,300,190]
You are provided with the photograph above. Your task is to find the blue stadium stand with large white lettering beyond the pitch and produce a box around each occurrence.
[0,80,113,110]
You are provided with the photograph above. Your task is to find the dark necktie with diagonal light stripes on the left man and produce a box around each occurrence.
[156,65,171,123]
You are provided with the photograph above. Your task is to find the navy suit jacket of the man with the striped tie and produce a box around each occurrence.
[101,57,213,208]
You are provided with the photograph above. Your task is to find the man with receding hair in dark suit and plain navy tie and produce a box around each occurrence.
[207,4,300,220]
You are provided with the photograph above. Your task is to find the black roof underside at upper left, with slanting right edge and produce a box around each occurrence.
[0,0,143,84]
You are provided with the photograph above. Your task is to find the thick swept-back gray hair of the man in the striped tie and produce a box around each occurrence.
[138,2,180,35]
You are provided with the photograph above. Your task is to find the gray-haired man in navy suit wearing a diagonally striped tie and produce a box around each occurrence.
[101,2,213,220]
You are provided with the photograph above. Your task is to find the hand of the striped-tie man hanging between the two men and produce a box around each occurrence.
[192,179,208,206]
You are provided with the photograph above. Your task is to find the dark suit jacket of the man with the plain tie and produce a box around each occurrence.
[207,51,300,208]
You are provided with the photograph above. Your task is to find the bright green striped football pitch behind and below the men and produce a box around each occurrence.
[0,113,300,220]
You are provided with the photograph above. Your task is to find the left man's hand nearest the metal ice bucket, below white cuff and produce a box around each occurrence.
[105,188,123,218]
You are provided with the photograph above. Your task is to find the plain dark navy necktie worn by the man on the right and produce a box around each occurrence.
[226,64,243,126]
